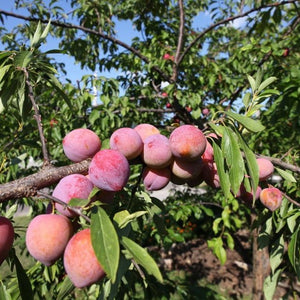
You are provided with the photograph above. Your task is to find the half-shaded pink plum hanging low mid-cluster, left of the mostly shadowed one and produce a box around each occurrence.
[143,167,171,191]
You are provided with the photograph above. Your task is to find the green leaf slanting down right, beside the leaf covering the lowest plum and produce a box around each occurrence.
[121,236,163,282]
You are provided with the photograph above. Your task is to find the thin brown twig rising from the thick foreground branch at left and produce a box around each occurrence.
[23,68,50,166]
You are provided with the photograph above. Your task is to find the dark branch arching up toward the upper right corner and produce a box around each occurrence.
[178,0,299,65]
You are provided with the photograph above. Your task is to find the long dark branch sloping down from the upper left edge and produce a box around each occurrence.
[0,9,171,82]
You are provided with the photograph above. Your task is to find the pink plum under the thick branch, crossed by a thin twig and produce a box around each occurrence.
[52,174,94,217]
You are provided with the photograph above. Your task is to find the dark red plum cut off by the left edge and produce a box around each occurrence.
[0,216,15,266]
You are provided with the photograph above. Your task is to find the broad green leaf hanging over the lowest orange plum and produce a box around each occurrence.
[91,207,120,282]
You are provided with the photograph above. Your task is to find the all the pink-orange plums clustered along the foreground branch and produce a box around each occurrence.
[0,124,282,288]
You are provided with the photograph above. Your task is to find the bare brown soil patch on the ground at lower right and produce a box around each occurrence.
[154,232,300,300]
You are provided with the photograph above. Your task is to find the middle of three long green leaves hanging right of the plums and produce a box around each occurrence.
[222,127,245,195]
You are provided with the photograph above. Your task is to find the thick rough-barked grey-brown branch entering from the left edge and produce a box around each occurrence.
[0,160,90,202]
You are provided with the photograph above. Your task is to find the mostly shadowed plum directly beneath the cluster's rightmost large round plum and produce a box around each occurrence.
[171,158,203,180]
